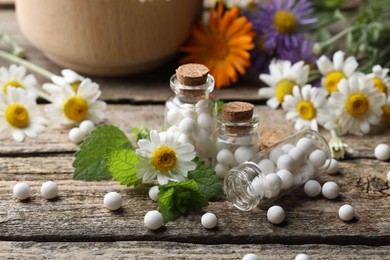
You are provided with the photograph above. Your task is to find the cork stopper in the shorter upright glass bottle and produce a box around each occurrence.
[222,101,255,123]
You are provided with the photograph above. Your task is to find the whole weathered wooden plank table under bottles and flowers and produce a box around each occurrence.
[0,5,390,259]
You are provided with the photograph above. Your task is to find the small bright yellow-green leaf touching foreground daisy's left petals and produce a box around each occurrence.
[107,149,142,186]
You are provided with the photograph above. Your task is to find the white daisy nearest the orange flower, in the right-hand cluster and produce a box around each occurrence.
[259,60,309,109]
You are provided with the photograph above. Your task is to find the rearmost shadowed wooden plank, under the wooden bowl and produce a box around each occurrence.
[0,9,261,103]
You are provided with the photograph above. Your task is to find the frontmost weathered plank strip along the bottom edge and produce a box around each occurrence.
[0,241,390,260]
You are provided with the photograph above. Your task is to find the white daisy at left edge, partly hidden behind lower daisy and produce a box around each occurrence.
[0,64,37,98]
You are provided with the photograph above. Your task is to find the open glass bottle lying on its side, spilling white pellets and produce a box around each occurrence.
[224,130,331,211]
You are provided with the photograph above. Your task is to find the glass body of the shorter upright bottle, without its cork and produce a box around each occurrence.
[213,115,260,178]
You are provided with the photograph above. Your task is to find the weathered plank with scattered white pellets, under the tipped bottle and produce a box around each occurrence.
[0,155,390,245]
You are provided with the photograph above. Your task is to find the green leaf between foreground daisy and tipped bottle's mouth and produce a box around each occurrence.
[188,158,223,200]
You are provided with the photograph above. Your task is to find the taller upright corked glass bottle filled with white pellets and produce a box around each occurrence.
[164,64,216,164]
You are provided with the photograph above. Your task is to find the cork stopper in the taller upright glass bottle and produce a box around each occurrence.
[176,63,209,86]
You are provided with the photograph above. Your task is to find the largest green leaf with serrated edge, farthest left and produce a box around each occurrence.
[73,125,132,181]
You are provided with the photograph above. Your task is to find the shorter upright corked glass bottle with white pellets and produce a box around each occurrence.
[213,101,260,178]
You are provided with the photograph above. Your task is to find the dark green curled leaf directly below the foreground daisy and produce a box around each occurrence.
[157,180,208,223]
